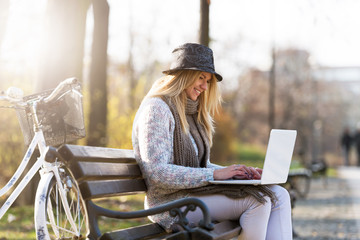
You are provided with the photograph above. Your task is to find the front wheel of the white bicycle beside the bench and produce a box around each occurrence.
[35,168,88,239]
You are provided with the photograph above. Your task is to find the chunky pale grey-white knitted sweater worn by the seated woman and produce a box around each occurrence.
[132,98,221,230]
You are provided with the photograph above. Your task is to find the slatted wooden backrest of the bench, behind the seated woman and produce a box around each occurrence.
[58,145,147,200]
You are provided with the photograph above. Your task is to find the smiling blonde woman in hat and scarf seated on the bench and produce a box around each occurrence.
[132,43,292,240]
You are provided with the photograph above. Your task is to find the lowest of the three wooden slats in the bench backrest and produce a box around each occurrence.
[79,179,147,200]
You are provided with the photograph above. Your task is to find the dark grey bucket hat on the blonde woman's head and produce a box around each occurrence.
[163,43,222,81]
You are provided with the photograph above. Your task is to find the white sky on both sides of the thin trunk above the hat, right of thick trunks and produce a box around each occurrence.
[105,0,360,66]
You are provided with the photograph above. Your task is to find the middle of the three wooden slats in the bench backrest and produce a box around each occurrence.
[70,162,142,182]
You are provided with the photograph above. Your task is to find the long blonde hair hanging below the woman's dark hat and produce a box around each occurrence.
[146,70,221,146]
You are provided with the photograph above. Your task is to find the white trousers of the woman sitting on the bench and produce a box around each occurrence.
[187,185,292,240]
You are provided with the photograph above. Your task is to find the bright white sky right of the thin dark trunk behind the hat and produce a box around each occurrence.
[213,0,360,66]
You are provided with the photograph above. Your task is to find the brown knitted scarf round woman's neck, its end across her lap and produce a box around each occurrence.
[162,97,276,203]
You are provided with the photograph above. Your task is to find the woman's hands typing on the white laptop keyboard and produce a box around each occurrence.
[214,165,262,180]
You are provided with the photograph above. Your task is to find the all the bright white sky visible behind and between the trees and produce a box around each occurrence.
[0,0,360,84]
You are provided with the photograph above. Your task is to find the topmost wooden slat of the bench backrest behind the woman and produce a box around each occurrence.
[58,145,136,163]
